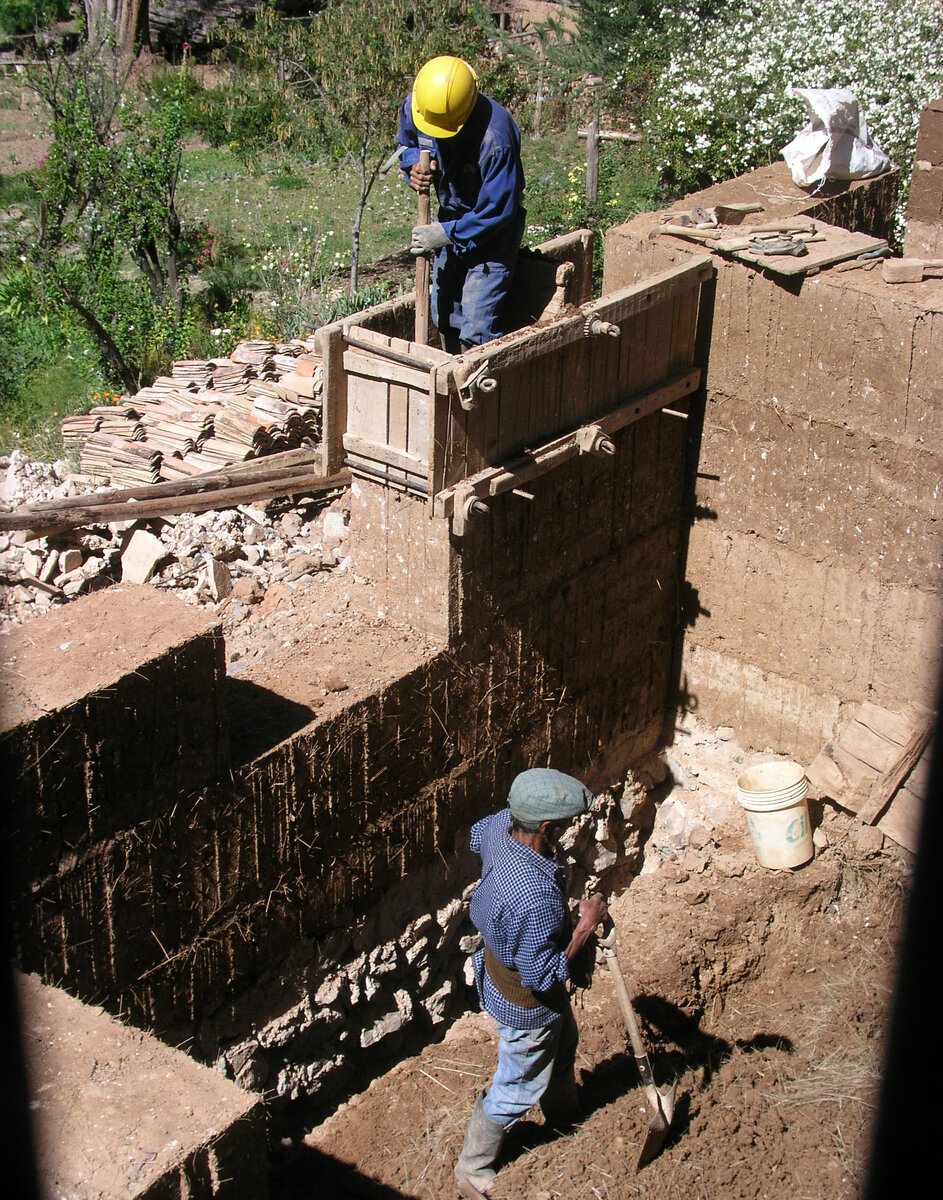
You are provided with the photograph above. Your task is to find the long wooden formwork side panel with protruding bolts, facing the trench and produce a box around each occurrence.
[431,258,714,530]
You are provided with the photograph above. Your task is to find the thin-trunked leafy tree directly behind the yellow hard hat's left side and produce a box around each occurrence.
[206,0,486,293]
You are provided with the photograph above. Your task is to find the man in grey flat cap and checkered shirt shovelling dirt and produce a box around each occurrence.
[455,768,607,1200]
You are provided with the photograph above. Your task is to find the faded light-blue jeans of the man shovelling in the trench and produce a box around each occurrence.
[481,1004,579,1129]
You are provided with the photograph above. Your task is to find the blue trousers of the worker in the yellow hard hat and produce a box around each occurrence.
[431,215,524,354]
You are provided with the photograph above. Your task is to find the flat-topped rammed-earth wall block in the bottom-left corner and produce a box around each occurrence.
[18,976,269,1200]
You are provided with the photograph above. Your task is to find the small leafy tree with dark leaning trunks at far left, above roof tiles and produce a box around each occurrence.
[18,29,186,390]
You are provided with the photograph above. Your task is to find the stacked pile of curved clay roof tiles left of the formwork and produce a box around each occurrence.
[62,341,323,487]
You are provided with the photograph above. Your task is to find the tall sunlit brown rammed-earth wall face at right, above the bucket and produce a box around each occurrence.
[605,166,943,761]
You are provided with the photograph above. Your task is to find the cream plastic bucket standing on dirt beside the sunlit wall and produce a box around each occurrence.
[737,762,812,870]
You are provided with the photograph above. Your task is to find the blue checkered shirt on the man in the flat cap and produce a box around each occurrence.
[472,809,572,1030]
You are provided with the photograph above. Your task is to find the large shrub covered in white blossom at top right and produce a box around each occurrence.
[629,0,943,199]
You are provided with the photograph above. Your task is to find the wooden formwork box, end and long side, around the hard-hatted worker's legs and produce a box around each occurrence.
[341,256,714,498]
